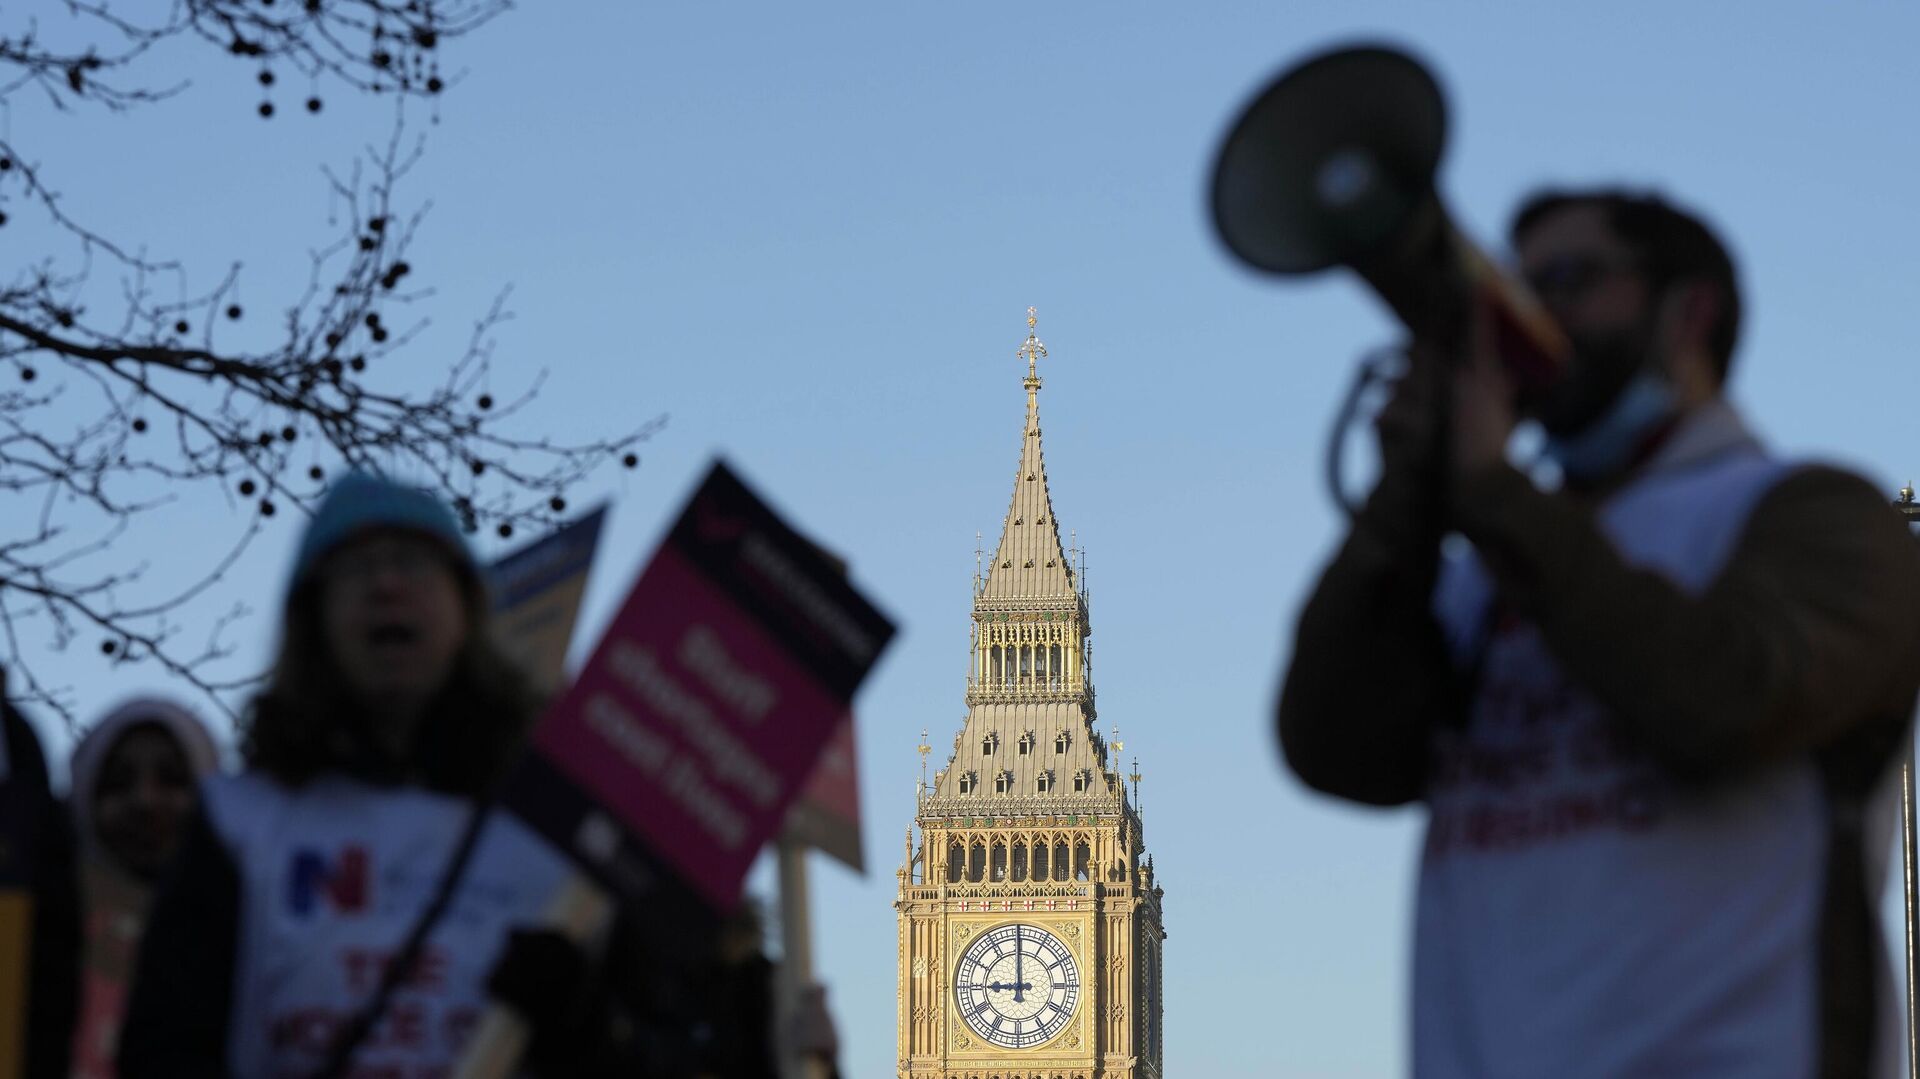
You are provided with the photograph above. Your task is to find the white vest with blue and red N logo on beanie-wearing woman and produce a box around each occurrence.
[205,776,568,1079]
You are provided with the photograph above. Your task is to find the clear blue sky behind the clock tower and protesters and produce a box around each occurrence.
[15,0,1920,1077]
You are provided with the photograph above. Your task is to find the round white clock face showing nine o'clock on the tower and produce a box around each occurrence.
[954,923,1079,1048]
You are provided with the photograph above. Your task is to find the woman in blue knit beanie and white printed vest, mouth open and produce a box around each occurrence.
[119,474,566,1079]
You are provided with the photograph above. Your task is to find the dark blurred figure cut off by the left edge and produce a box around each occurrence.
[0,670,81,1079]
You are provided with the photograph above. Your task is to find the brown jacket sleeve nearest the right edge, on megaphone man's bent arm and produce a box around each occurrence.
[1457,456,1920,778]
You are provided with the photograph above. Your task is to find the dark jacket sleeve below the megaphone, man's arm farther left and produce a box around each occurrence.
[1275,472,1463,806]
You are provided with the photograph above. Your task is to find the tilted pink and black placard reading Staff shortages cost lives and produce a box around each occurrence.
[505,465,893,910]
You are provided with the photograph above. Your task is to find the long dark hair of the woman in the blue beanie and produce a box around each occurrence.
[240,556,538,797]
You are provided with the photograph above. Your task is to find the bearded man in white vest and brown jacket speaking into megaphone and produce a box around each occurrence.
[1277,190,1920,1079]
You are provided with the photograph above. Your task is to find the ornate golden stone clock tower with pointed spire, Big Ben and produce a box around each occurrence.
[895,307,1165,1079]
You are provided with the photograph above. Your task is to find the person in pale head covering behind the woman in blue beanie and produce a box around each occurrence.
[71,697,219,1079]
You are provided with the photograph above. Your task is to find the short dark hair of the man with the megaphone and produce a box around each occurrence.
[1507,188,1740,384]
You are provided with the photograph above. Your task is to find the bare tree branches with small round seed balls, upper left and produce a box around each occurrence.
[0,0,664,724]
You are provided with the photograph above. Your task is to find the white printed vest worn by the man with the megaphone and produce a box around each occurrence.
[1413,437,1893,1079]
